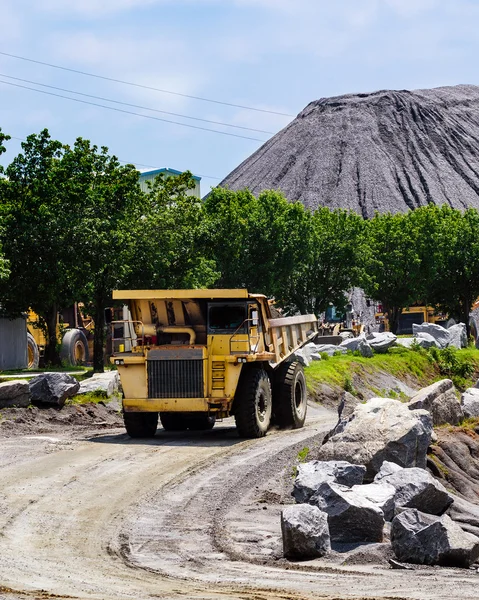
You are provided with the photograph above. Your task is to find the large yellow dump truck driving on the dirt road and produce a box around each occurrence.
[111,289,317,438]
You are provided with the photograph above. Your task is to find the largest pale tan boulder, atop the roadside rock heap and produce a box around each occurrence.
[317,398,433,480]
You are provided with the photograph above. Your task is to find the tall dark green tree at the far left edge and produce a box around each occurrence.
[0,129,78,364]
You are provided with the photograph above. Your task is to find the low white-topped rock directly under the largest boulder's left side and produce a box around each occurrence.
[293,460,366,503]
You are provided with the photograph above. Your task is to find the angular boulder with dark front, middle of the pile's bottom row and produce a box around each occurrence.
[311,481,384,543]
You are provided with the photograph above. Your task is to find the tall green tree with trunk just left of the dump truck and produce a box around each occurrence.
[58,138,148,372]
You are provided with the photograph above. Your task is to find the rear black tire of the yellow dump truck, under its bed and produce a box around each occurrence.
[273,361,308,429]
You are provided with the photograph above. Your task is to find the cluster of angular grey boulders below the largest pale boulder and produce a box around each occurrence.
[281,461,479,567]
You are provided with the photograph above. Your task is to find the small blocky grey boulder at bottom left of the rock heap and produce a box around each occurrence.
[281,504,331,559]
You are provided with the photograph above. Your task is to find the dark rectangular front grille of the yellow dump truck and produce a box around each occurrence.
[147,359,204,398]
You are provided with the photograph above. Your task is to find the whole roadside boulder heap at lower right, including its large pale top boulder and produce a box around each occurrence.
[282,380,479,567]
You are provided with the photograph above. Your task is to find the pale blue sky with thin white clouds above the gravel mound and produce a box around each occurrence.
[0,0,479,193]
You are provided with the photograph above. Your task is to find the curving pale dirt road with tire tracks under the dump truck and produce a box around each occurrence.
[0,410,479,600]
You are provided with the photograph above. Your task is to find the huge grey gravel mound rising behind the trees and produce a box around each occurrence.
[220,85,479,217]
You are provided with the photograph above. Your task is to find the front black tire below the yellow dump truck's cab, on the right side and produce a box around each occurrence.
[234,369,273,438]
